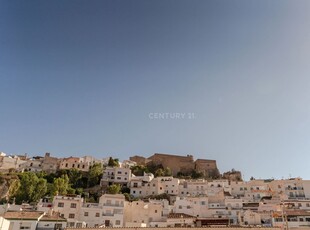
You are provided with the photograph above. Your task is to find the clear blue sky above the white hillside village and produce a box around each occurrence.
[0,0,310,179]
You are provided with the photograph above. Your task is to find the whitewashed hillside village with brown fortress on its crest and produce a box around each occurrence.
[0,153,310,230]
